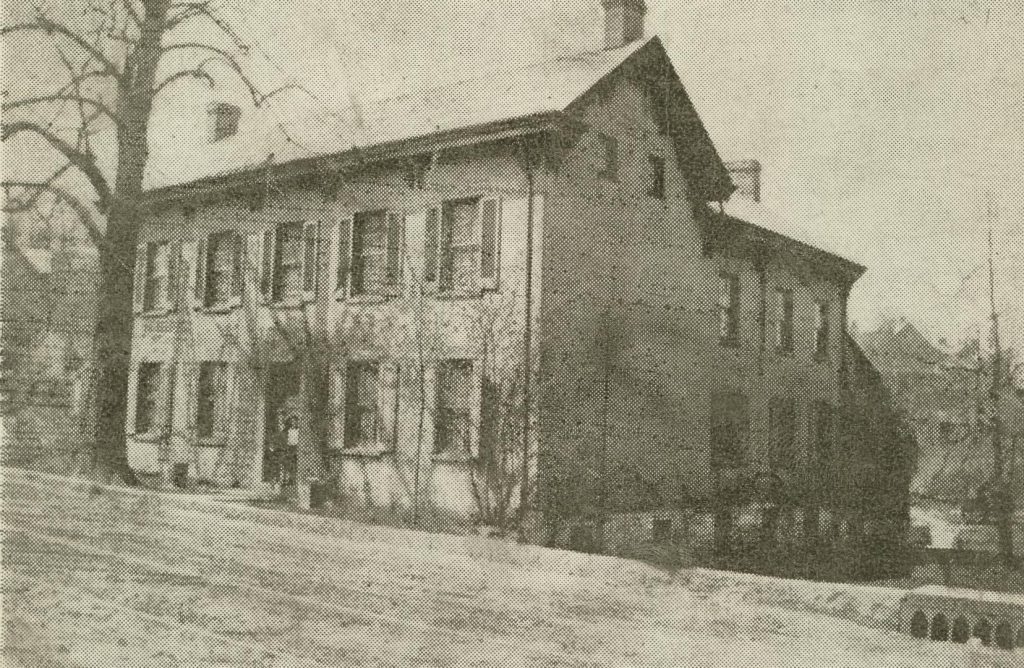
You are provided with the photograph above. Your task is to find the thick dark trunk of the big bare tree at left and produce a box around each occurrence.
[92,0,171,484]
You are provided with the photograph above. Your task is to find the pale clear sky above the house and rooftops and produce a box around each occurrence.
[6,0,1024,354]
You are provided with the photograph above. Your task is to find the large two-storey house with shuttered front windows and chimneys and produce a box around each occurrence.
[126,0,913,573]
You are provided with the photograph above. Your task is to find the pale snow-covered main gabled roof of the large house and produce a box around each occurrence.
[144,37,731,200]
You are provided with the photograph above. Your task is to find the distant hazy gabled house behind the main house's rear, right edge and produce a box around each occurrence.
[861,318,1024,501]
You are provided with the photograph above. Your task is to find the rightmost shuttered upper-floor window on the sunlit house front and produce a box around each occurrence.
[423,198,501,295]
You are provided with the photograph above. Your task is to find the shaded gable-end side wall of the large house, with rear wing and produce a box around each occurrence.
[539,73,844,549]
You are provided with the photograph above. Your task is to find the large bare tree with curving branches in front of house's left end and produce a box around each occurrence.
[0,0,284,482]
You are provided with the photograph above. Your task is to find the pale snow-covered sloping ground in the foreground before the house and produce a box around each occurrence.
[2,469,1022,668]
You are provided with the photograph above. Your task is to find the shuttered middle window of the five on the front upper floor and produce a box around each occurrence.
[260,221,319,303]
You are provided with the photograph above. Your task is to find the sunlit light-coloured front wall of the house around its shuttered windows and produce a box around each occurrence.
[126,139,544,516]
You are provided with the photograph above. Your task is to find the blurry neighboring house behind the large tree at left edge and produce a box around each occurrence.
[0,204,96,472]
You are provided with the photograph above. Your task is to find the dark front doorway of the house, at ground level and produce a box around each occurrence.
[263,363,302,485]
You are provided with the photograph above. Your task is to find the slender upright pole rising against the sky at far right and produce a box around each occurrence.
[986,193,1015,569]
